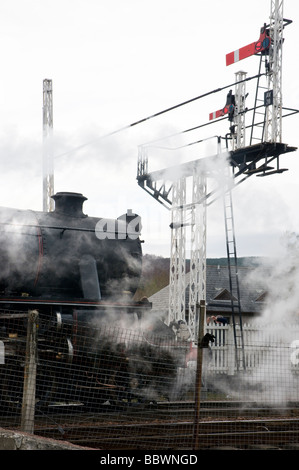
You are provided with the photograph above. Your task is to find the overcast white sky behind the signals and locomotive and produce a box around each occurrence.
[0,0,299,257]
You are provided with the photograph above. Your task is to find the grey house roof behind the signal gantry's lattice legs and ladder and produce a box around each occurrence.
[149,265,267,314]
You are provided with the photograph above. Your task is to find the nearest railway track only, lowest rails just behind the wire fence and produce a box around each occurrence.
[34,419,299,450]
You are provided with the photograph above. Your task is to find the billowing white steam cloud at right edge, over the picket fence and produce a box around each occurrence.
[216,233,299,404]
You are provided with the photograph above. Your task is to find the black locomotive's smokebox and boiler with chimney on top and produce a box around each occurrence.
[0,192,142,300]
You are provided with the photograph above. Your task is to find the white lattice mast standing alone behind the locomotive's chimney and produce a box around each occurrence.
[43,79,54,212]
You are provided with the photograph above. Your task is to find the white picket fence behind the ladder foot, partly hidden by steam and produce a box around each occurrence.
[205,324,299,375]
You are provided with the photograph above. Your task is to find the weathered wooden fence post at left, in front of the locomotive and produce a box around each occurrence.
[21,310,38,434]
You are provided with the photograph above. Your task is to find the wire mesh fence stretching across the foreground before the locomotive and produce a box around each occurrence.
[0,312,299,450]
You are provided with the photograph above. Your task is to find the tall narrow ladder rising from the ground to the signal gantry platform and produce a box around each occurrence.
[223,189,246,371]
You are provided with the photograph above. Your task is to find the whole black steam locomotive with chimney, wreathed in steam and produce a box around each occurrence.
[0,192,188,406]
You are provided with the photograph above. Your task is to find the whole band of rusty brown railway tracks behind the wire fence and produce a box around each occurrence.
[25,402,299,451]
